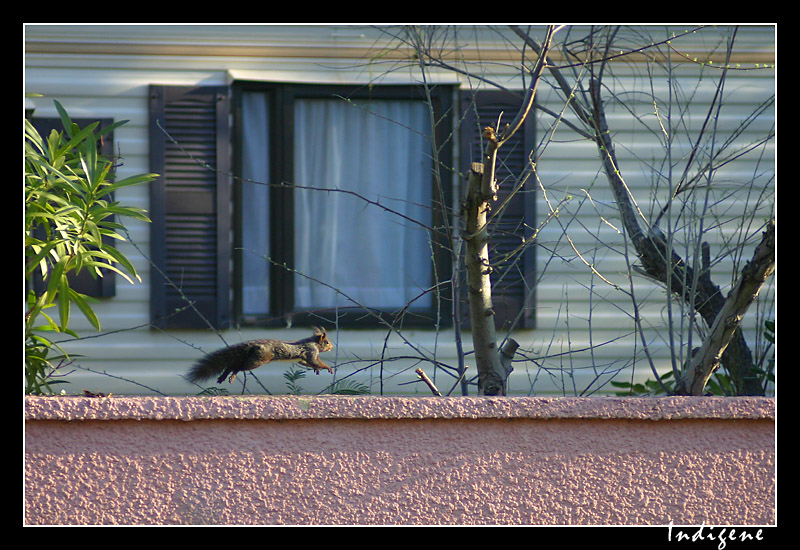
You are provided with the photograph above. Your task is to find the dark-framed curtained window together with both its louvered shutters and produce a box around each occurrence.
[150,82,535,328]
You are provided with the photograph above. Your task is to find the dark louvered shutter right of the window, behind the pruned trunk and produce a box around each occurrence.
[460,91,536,330]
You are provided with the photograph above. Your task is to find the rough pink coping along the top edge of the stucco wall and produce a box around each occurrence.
[25,396,776,422]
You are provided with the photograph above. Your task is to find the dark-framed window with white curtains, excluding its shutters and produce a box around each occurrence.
[234,83,451,324]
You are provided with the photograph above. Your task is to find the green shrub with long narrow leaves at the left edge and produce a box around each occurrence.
[25,101,156,394]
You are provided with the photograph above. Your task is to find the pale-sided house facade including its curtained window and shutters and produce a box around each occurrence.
[24,25,776,395]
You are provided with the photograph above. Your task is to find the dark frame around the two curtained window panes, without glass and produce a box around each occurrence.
[231,81,455,327]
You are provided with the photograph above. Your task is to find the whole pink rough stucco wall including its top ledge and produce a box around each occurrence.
[25,397,776,525]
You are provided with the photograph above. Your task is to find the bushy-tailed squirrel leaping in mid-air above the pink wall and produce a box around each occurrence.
[184,327,333,384]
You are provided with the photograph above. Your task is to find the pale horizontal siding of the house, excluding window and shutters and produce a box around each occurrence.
[25,26,775,395]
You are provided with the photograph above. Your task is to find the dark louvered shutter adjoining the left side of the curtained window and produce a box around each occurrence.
[150,86,231,328]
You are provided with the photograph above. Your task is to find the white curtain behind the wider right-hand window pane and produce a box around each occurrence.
[294,99,432,309]
